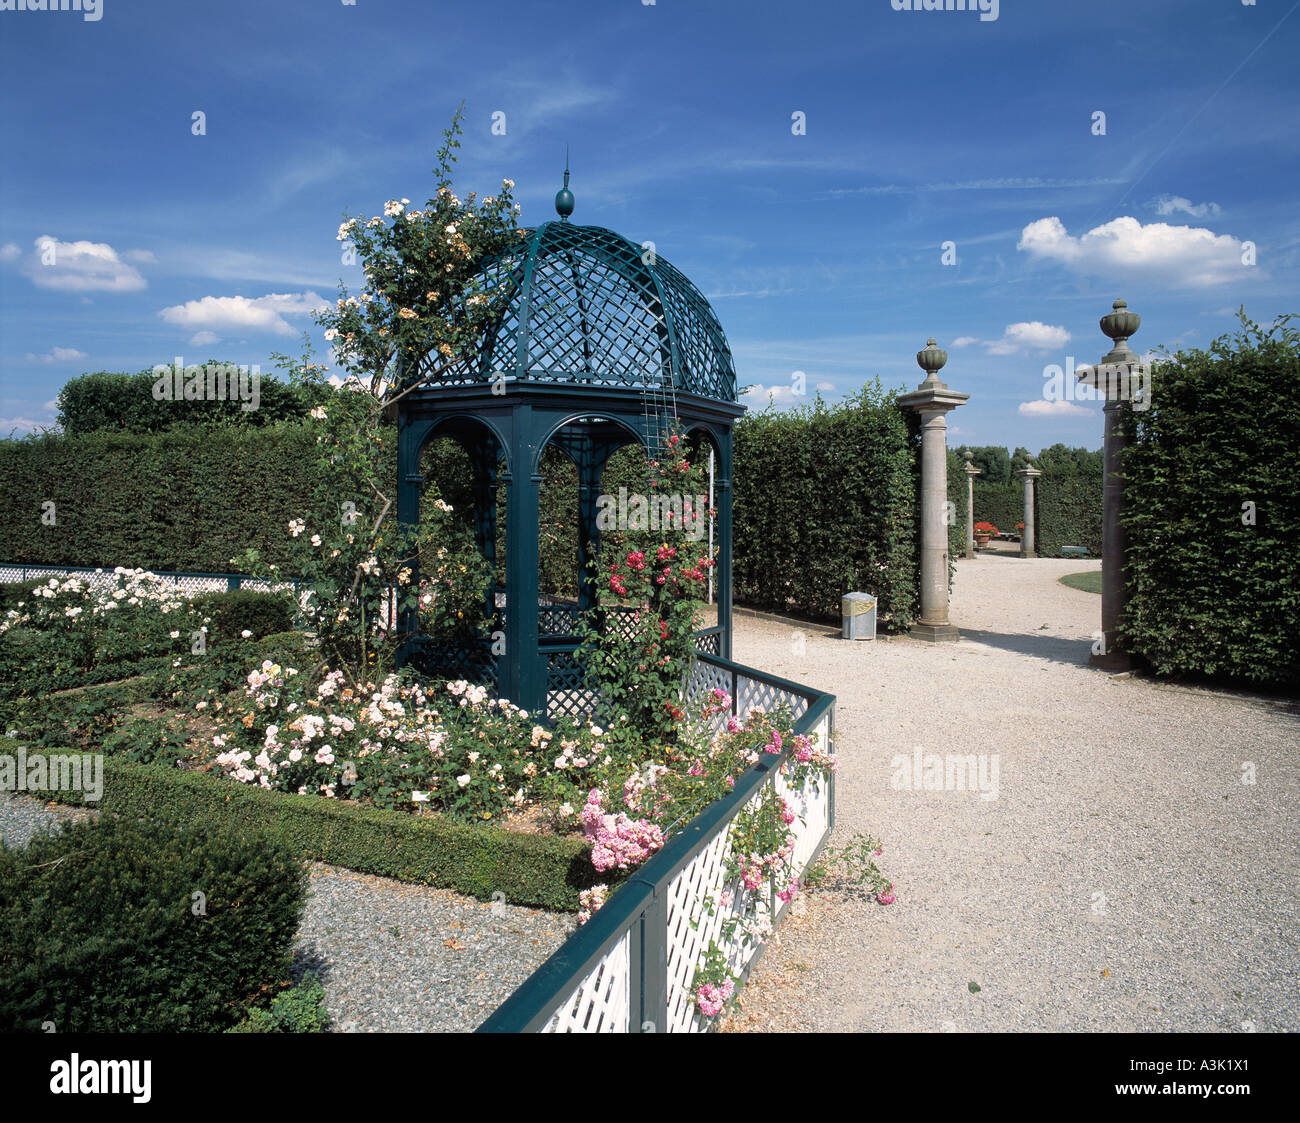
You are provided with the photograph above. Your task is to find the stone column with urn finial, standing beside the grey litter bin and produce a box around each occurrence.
[898,339,971,643]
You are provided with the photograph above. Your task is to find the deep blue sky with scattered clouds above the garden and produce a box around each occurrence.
[0,0,1300,451]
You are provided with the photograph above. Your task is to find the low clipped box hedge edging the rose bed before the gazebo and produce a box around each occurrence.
[0,738,602,912]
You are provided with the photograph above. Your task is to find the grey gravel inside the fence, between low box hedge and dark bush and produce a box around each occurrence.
[0,793,577,1032]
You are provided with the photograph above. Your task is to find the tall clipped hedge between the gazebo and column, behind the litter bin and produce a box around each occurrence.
[733,381,918,630]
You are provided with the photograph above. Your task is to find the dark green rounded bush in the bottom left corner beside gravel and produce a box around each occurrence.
[0,815,307,1033]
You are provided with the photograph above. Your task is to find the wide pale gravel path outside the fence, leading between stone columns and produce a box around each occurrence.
[728,556,1300,1032]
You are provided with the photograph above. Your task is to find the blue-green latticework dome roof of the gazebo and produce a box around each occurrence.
[430,222,736,402]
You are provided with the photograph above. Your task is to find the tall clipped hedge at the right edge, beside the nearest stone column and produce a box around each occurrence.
[1122,316,1300,689]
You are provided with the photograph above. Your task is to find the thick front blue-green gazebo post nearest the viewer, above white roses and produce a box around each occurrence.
[499,403,546,716]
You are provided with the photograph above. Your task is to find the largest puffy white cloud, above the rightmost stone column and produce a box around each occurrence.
[1017,217,1249,286]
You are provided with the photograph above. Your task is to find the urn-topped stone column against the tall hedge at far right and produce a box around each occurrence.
[1076,300,1141,671]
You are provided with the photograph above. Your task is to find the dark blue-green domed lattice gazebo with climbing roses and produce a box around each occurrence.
[398,170,744,717]
